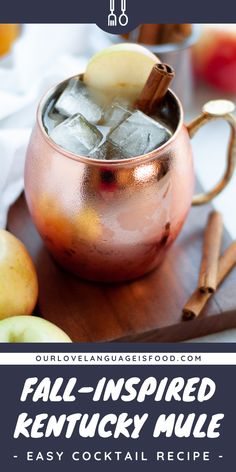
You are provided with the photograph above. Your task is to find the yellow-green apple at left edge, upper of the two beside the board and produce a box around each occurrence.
[0,229,38,319]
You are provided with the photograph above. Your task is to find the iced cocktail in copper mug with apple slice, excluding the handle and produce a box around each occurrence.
[25,45,235,282]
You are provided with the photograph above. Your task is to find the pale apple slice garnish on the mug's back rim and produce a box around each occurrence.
[84,43,160,97]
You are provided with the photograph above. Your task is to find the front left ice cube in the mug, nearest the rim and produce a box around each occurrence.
[50,113,103,156]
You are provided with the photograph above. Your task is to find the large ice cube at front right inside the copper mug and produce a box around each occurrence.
[107,111,171,157]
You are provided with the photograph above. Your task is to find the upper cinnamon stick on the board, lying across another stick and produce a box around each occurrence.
[198,211,223,293]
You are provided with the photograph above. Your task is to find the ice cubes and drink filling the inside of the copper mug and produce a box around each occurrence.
[43,73,172,161]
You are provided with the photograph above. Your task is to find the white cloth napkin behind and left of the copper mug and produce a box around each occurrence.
[0,24,91,227]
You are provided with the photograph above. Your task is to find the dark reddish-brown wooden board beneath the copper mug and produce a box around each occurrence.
[8,195,236,342]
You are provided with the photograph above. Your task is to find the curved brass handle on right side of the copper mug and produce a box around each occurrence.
[187,100,236,205]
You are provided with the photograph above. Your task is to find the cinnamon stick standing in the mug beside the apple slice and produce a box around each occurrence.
[136,63,175,114]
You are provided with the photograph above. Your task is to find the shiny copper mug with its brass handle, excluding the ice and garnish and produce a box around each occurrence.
[25,75,236,282]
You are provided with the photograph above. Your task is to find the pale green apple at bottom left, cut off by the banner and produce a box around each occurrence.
[0,316,72,343]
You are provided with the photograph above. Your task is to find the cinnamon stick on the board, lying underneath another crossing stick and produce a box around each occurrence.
[183,241,236,320]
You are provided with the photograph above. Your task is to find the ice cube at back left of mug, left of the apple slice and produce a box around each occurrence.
[55,79,103,123]
